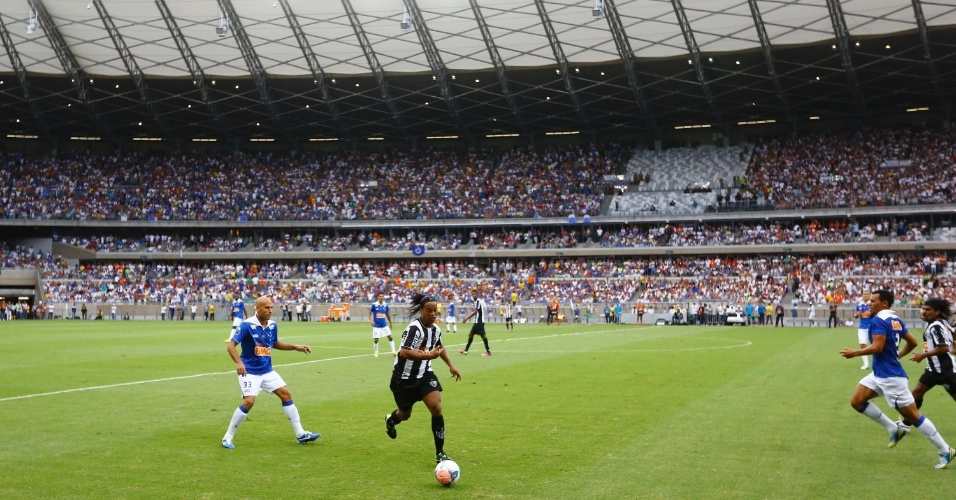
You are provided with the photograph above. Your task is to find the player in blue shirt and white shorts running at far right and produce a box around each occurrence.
[840,290,956,469]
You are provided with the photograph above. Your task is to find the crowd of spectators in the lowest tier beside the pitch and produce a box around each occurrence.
[0,234,956,304]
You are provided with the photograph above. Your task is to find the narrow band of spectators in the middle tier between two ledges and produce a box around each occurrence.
[54,218,933,253]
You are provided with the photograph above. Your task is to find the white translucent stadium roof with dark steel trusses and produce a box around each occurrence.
[0,0,956,140]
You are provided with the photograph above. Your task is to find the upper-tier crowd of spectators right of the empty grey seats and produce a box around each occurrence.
[746,127,956,209]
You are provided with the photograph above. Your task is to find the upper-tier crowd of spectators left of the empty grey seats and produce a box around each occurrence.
[0,145,629,221]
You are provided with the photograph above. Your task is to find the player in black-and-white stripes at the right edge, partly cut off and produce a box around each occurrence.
[910,298,956,408]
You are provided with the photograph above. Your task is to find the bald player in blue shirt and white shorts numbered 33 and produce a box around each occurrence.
[222,296,320,450]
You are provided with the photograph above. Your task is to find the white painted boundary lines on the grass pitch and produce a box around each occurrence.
[0,326,752,403]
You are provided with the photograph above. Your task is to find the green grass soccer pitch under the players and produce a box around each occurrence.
[0,321,956,499]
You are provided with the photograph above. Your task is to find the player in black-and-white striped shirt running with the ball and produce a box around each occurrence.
[385,293,461,462]
